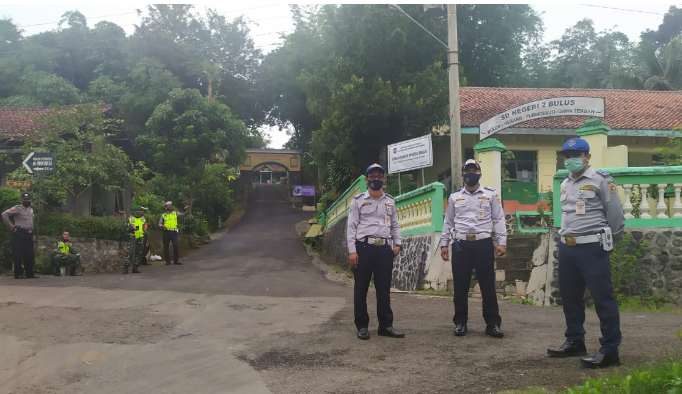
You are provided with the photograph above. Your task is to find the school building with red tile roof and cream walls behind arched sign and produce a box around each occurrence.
[418,87,682,212]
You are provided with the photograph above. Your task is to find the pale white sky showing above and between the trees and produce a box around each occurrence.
[0,0,682,148]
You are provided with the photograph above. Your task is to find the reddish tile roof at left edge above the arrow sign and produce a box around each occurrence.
[0,104,112,141]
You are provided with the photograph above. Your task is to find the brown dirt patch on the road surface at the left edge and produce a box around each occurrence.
[0,302,177,347]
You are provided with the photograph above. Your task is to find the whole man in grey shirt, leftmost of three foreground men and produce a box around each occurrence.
[346,164,405,339]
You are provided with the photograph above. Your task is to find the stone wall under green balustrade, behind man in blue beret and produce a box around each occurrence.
[528,228,682,308]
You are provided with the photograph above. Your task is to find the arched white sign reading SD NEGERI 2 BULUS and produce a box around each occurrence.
[479,97,604,139]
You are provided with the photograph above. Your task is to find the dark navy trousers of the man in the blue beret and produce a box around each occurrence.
[559,242,621,354]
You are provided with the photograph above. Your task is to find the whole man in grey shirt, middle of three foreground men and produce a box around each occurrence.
[440,160,507,338]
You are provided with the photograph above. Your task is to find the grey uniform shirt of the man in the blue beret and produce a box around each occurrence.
[559,166,625,241]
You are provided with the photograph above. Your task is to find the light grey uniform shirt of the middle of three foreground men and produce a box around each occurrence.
[440,186,507,246]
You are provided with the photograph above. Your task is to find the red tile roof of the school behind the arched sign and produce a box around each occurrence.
[460,87,682,130]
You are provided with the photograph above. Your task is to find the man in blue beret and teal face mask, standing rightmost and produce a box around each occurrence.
[547,138,625,368]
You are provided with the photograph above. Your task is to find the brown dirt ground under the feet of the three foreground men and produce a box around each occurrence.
[239,293,682,394]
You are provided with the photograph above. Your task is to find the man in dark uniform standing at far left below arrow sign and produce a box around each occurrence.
[2,193,38,279]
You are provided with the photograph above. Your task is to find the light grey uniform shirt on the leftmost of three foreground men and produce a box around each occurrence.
[346,192,402,253]
